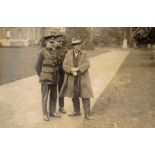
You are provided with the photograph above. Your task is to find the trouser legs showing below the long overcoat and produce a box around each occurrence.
[72,97,90,115]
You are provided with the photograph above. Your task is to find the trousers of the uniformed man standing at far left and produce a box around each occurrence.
[41,84,57,115]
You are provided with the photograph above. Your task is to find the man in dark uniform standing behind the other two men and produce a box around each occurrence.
[55,34,67,114]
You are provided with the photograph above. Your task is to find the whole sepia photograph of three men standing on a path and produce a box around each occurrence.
[0,27,155,128]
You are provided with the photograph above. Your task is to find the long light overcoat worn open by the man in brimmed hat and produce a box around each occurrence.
[60,50,93,98]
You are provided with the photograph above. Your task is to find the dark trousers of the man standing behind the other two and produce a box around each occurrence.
[58,69,64,108]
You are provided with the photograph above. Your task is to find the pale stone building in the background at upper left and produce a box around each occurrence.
[0,27,65,47]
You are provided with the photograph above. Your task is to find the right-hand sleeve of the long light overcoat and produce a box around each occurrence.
[78,53,90,73]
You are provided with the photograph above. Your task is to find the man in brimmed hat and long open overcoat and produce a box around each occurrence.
[60,37,93,120]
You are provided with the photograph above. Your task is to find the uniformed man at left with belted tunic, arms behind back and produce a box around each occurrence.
[36,37,60,121]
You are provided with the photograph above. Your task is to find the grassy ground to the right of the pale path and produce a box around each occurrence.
[80,49,155,128]
